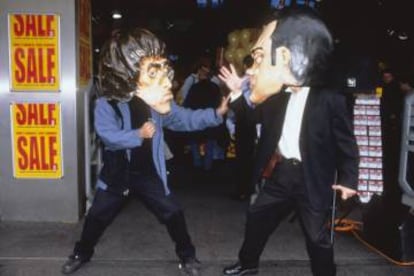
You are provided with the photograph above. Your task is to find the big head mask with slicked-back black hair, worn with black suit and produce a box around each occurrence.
[251,9,332,103]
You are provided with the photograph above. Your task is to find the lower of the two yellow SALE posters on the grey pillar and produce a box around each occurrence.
[10,103,63,179]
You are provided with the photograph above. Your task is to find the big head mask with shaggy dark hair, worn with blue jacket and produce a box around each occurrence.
[99,28,173,113]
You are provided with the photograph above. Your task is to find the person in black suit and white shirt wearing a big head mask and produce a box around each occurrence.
[220,7,359,276]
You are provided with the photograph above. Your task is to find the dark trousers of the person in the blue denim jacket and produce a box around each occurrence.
[74,174,195,260]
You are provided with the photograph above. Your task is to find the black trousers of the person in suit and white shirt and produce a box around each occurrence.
[239,159,336,276]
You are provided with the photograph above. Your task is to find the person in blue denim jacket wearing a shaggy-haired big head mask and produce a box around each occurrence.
[62,28,227,275]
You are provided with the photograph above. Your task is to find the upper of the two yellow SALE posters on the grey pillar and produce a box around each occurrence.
[9,13,60,92]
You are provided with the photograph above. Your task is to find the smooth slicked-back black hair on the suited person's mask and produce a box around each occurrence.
[272,8,333,86]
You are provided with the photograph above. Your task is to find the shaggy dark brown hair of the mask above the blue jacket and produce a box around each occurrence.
[98,28,166,99]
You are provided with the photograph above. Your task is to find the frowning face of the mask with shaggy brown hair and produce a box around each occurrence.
[136,57,174,114]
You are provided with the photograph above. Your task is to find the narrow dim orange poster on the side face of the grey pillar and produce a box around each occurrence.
[78,0,92,86]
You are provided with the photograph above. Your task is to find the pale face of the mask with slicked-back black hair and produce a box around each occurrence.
[250,21,284,103]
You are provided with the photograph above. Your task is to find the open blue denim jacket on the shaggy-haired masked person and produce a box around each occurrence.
[94,97,223,195]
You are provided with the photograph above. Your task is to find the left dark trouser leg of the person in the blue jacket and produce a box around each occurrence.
[74,189,125,260]
